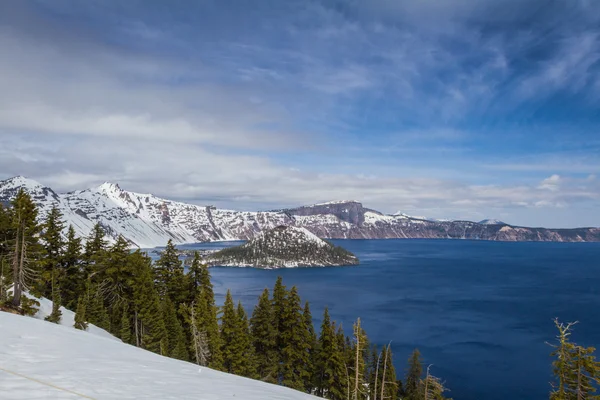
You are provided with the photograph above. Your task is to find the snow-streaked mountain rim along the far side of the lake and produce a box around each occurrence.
[0,177,600,247]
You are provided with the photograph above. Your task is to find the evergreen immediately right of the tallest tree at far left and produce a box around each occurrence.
[36,205,64,298]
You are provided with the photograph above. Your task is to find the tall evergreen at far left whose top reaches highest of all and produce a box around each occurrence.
[9,189,41,308]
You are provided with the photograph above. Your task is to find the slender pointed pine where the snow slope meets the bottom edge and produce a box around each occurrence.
[315,308,347,400]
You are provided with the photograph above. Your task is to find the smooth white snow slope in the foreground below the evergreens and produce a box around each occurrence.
[0,312,316,400]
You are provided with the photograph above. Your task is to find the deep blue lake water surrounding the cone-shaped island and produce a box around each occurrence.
[173,240,600,400]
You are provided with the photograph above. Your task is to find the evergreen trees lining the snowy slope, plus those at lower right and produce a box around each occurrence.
[0,191,600,400]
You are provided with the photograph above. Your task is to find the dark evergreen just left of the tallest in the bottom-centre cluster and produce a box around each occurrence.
[250,289,278,383]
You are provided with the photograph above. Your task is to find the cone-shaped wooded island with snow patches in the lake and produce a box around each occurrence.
[205,226,358,269]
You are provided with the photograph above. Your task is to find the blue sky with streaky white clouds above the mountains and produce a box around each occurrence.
[0,0,600,227]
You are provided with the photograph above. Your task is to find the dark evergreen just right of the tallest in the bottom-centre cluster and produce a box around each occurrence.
[281,286,311,390]
